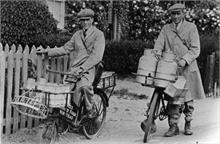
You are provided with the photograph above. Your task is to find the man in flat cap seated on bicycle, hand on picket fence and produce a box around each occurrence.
[38,8,105,118]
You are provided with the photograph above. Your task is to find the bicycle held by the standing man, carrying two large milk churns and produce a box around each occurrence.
[134,73,187,143]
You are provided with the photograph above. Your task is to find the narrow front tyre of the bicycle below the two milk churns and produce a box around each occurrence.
[143,91,159,143]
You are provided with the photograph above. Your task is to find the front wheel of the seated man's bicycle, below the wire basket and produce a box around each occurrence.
[39,122,58,144]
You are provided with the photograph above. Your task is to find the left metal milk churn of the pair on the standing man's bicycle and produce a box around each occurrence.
[136,49,157,85]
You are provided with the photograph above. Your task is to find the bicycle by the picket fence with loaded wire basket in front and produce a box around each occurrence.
[11,54,116,144]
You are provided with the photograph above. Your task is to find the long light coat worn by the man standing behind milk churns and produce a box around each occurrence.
[154,20,205,101]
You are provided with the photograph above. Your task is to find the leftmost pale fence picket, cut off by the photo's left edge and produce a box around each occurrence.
[0,46,5,143]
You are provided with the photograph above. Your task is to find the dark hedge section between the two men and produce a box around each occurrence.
[103,40,152,75]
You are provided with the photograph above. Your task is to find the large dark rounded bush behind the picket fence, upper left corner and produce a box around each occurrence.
[1,0,57,46]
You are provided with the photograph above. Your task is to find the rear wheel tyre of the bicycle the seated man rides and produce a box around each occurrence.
[82,92,107,139]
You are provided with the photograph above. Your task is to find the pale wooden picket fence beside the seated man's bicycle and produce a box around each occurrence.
[0,43,69,137]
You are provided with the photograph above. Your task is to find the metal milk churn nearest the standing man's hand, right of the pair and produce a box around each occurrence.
[154,51,177,88]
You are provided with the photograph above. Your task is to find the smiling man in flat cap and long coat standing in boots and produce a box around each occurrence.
[142,3,205,137]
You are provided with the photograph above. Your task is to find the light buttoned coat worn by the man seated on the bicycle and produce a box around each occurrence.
[48,26,105,86]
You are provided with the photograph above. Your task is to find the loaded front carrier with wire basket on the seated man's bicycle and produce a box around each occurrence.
[11,79,71,119]
